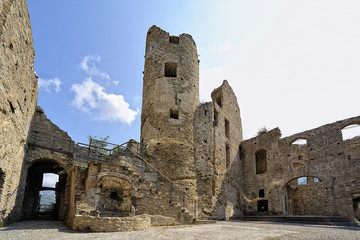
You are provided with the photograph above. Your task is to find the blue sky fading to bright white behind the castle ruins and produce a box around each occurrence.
[28,0,360,144]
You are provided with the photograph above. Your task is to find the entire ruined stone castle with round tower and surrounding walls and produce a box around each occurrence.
[0,0,360,231]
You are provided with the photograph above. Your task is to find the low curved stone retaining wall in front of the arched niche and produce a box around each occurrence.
[72,215,151,232]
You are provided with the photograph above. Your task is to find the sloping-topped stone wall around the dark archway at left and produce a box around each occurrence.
[16,106,74,220]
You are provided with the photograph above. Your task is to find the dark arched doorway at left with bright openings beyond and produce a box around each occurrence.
[23,160,67,220]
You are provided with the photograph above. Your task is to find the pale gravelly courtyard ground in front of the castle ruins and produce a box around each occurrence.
[0,220,360,240]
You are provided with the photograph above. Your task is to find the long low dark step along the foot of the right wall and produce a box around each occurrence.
[231,215,357,226]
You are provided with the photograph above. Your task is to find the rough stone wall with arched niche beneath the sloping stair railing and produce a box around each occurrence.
[70,156,193,225]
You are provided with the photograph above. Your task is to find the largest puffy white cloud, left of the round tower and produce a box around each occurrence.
[71,78,139,125]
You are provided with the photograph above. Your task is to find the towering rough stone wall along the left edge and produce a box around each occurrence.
[0,0,37,222]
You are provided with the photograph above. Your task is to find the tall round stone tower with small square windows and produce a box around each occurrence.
[141,26,199,193]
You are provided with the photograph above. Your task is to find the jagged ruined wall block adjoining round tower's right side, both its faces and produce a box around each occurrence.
[196,80,242,219]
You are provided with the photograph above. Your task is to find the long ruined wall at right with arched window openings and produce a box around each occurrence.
[240,117,360,220]
